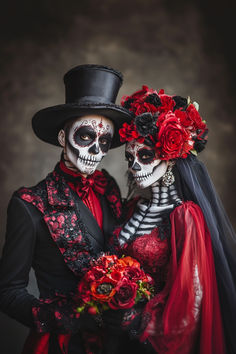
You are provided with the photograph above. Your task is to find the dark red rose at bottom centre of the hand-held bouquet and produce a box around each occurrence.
[108,278,138,310]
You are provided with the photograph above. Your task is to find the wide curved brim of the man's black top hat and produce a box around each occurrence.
[32,103,132,149]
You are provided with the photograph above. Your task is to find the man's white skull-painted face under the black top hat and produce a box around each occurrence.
[65,115,114,175]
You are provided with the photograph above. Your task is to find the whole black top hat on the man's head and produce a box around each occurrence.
[32,65,132,148]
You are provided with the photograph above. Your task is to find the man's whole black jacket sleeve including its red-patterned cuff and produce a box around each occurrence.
[0,196,100,333]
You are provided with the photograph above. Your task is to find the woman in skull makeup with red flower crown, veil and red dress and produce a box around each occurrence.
[111,86,236,354]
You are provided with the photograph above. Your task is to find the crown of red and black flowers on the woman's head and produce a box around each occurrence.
[119,86,208,160]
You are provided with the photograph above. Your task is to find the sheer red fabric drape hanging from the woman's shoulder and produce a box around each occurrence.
[141,202,225,354]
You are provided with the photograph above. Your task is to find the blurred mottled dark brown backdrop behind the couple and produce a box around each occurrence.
[0,0,236,354]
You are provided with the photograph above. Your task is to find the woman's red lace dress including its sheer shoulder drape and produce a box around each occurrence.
[111,202,225,354]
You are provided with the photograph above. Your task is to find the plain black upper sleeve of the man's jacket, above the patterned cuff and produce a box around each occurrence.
[0,196,38,327]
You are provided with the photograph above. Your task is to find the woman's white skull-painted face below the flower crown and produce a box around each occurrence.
[125,140,168,188]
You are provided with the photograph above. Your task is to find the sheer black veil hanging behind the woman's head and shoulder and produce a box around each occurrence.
[174,155,236,354]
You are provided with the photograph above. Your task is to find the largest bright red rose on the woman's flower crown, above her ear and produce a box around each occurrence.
[156,112,194,160]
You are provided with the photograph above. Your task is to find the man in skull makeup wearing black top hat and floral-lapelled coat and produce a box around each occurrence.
[0,65,131,354]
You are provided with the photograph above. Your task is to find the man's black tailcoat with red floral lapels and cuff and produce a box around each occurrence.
[0,166,121,352]
